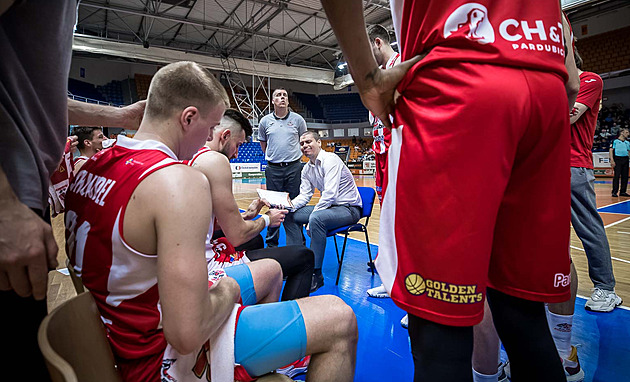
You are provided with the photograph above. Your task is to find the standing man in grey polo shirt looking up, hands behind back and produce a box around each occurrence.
[258,88,306,247]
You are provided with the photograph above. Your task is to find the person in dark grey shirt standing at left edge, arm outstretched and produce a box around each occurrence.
[0,1,146,381]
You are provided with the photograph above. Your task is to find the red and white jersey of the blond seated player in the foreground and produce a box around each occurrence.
[65,136,180,375]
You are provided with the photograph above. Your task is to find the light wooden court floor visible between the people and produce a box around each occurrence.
[48,176,630,310]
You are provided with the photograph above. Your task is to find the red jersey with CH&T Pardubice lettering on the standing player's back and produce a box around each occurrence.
[391,0,567,88]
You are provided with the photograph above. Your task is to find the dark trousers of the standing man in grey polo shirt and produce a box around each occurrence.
[265,161,306,247]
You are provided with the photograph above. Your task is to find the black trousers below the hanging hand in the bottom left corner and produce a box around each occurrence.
[0,210,50,381]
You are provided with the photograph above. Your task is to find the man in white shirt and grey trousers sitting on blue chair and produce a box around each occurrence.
[285,131,362,293]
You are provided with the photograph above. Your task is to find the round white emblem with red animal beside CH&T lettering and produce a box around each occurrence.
[444,3,494,44]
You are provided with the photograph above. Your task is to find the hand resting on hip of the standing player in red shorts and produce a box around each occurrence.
[357,56,423,127]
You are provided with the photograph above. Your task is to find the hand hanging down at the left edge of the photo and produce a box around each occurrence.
[0,198,57,300]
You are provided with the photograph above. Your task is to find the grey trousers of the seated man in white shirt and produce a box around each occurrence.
[284,206,361,269]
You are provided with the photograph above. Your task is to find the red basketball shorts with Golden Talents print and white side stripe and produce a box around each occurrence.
[376,63,571,326]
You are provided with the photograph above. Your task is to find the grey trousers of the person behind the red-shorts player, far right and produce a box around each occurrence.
[571,167,615,290]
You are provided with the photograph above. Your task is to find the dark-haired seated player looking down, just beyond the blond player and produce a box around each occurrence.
[188,109,314,301]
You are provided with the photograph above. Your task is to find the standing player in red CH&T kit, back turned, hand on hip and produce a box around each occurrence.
[322,0,577,381]
